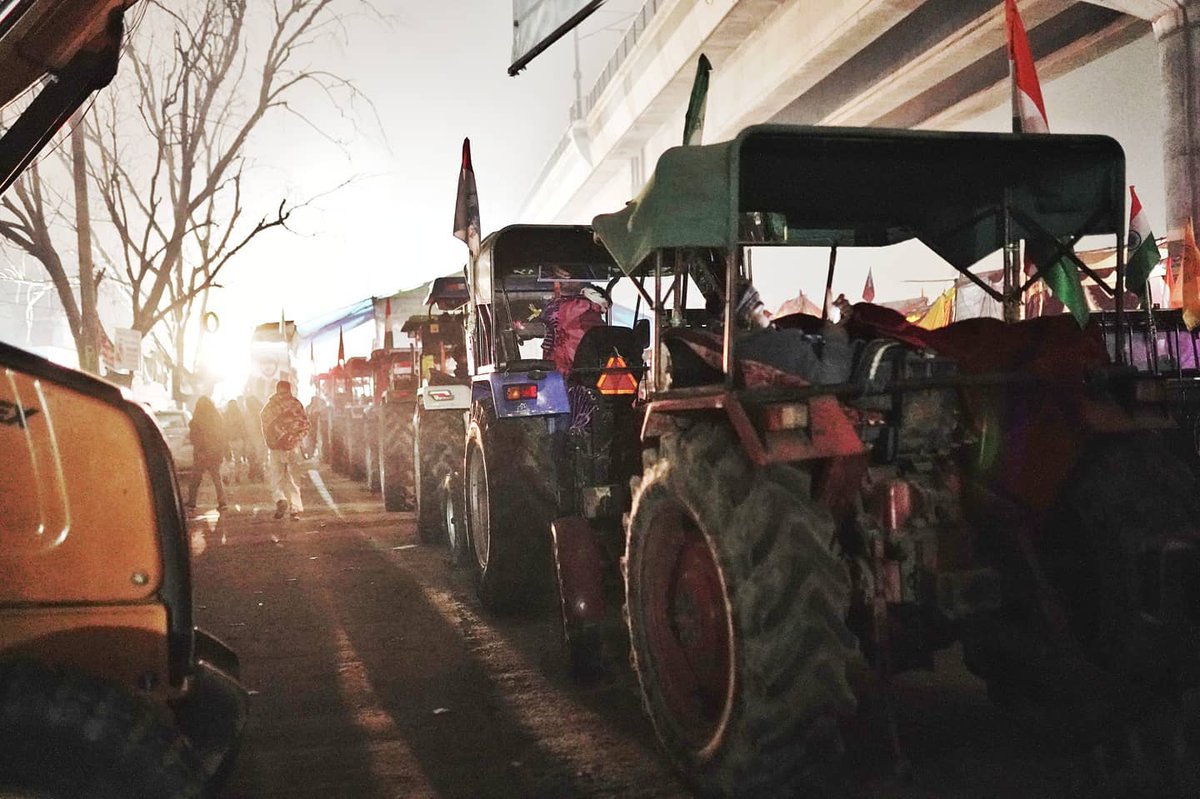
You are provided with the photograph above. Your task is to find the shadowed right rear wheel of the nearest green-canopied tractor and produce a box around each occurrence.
[1039,434,1200,714]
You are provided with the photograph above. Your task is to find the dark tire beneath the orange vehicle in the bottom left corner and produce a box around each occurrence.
[0,660,204,799]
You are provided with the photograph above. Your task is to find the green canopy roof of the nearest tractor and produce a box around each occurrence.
[592,126,1124,272]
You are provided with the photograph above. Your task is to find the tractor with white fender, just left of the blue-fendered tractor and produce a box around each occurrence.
[402,277,470,542]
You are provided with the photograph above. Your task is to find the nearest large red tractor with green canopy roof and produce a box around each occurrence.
[544,126,1200,797]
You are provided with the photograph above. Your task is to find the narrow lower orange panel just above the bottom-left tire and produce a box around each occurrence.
[0,603,169,695]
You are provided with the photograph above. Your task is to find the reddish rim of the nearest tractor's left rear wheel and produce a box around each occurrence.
[642,505,733,751]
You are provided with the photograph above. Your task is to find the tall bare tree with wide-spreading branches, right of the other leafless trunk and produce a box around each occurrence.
[90,0,371,391]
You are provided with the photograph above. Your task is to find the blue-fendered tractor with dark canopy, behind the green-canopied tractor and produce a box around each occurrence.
[462,224,620,612]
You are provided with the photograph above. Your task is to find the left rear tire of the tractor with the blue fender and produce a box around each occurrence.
[463,402,566,613]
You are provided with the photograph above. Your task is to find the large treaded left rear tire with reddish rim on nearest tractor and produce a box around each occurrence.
[625,423,858,797]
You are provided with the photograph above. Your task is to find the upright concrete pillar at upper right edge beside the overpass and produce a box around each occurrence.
[1154,0,1200,239]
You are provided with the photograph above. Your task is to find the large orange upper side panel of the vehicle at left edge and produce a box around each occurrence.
[0,370,162,599]
